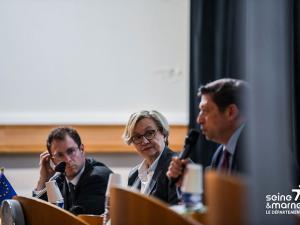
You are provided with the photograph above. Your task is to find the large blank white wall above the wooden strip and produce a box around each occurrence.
[0,0,189,124]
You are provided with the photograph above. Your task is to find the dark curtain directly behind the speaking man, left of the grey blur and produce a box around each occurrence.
[189,0,245,167]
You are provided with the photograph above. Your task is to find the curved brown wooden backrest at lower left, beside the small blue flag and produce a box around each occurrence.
[14,196,88,225]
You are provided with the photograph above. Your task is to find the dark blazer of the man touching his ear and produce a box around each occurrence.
[36,159,112,215]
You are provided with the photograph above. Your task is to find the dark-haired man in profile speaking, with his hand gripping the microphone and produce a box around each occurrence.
[167,79,249,178]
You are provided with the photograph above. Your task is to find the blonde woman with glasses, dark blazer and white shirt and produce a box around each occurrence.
[123,110,179,205]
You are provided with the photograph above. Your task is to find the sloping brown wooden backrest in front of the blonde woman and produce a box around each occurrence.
[110,187,200,225]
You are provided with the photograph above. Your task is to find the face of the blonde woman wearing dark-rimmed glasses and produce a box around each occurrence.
[133,118,165,163]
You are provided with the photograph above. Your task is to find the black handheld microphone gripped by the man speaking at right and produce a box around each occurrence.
[170,129,199,187]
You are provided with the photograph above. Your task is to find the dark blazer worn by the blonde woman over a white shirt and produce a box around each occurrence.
[128,147,179,205]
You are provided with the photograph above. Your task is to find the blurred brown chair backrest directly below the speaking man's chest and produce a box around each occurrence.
[205,170,247,225]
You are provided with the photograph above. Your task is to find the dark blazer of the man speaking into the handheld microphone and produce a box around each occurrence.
[210,127,247,174]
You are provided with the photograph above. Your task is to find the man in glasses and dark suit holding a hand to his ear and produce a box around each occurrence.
[33,127,112,215]
